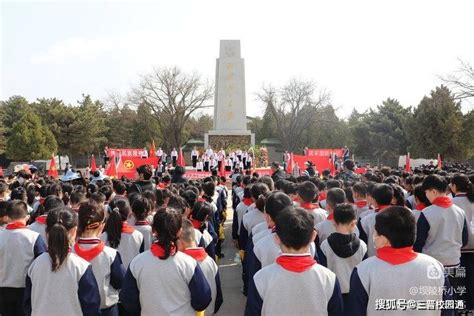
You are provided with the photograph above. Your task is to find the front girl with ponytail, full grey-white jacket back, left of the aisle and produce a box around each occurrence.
[120,208,212,316]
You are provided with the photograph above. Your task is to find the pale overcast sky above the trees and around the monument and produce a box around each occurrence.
[0,0,474,117]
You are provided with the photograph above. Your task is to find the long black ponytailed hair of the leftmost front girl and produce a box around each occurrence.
[46,206,78,272]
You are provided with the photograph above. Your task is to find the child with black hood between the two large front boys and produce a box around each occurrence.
[318,203,367,306]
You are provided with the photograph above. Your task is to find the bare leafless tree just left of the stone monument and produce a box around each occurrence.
[132,67,213,149]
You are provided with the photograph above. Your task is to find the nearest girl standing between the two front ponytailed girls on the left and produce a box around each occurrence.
[73,202,125,316]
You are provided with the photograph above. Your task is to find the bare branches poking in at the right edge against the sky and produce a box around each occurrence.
[441,59,474,99]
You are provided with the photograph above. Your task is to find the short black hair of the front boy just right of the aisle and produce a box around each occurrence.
[275,206,314,250]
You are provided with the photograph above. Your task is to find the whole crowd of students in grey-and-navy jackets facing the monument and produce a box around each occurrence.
[0,159,474,315]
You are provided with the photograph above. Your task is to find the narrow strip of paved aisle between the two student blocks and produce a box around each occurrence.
[219,202,246,316]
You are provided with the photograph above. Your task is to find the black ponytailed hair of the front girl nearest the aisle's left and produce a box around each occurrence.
[152,208,183,260]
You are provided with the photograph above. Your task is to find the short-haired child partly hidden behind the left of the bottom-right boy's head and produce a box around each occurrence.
[357,183,393,257]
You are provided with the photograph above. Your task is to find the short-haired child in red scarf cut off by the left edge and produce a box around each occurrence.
[0,200,47,315]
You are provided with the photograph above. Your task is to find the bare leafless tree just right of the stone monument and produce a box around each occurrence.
[258,79,329,151]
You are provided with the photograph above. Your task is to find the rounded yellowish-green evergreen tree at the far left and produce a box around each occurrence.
[6,111,58,161]
